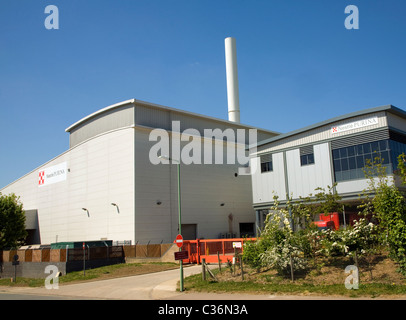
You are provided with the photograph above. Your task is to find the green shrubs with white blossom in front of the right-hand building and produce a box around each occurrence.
[243,154,406,275]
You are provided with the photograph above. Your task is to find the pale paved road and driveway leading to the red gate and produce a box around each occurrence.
[0,266,406,301]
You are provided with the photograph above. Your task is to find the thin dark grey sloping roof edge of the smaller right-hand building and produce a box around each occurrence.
[252,105,406,147]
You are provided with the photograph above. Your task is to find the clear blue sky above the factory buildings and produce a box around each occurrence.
[0,0,406,187]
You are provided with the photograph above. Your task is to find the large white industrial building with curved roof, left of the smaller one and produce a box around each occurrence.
[0,100,277,244]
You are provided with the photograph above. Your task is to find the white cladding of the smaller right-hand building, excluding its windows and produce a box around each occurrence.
[250,106,405,208]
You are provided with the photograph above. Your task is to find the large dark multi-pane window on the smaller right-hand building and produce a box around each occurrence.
[332,140,394,182]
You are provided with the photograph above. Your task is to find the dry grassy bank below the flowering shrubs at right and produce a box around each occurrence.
[185,255,406,299]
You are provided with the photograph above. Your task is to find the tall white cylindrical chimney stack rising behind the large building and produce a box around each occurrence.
[224,37,240,123]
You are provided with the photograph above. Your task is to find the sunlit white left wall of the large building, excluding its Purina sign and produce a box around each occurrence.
[1,129,134,243]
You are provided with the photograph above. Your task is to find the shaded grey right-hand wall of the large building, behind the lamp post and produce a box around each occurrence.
[135,128,255,243]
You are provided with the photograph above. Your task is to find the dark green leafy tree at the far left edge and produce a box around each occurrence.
[0,193,27,249]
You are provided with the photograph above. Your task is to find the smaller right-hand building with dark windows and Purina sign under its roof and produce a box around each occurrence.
[250,105,406,227]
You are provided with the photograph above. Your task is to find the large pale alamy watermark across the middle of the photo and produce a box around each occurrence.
[149,121,257,175]
